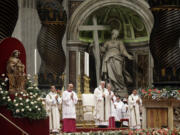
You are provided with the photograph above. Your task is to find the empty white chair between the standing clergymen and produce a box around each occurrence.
[82,94,95,126]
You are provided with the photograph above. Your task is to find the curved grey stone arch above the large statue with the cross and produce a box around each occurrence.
[67,0,154,41]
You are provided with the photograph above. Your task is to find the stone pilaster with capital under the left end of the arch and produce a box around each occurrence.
[66,41,87,92]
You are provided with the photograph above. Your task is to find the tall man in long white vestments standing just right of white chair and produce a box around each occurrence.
[94,81,113,127]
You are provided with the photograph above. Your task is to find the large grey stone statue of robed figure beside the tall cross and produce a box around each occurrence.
[100,29,133,96]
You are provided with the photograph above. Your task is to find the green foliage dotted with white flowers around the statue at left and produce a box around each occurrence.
[0,75,47,120]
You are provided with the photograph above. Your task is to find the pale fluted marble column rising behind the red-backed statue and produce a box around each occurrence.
[12,0,41,75]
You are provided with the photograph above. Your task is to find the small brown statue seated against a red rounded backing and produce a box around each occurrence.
[7,50,26,93]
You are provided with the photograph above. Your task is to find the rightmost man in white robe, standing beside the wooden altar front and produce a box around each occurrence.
[128,90,142,129]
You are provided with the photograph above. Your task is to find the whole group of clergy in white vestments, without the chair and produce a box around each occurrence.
[46,81,142,133]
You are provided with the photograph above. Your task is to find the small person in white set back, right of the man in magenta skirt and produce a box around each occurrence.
[114,96,124,128]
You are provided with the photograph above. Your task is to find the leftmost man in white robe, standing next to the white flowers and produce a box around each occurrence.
[46,85,62,132]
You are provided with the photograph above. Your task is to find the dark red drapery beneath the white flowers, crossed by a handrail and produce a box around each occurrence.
[0,107,49,135]
